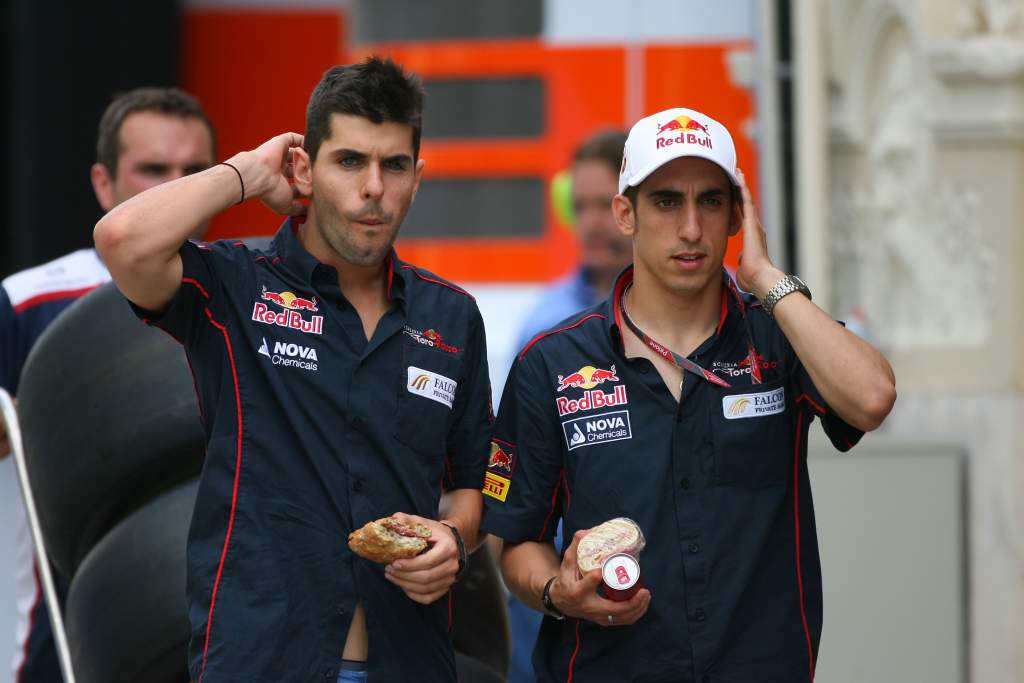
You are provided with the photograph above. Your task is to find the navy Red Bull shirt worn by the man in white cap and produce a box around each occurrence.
[482,268,862,683]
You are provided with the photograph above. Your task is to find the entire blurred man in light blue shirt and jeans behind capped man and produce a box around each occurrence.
[503,130,633,683]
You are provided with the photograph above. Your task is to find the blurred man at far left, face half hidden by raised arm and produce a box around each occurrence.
[0,88,216,683]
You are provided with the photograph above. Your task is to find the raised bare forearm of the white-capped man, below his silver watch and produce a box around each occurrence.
[754,271,896,431]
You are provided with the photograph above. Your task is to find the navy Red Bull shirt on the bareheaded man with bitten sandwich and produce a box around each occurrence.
[136,220,493,683]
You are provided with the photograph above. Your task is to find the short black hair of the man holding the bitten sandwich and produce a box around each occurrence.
[303,55,423,164]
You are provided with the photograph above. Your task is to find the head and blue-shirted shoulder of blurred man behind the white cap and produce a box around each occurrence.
[516,130,633,350]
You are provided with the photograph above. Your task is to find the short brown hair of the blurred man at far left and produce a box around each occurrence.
[96,88,217,178]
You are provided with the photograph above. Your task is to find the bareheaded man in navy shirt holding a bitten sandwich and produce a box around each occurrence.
[95,57,493,683]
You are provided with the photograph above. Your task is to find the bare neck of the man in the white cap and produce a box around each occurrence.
[626,269,722,355]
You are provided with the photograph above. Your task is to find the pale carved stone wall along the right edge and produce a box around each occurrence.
[821,0,1024,683]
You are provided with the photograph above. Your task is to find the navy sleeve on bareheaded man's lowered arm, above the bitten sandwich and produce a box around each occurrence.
[444,303,494,489]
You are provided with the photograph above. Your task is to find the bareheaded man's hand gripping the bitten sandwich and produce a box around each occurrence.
[384,512,459,605]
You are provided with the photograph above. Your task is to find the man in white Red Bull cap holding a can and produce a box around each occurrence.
[482,109,896,683]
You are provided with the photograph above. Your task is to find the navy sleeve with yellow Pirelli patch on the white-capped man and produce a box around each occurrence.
[481,349,564,543]
